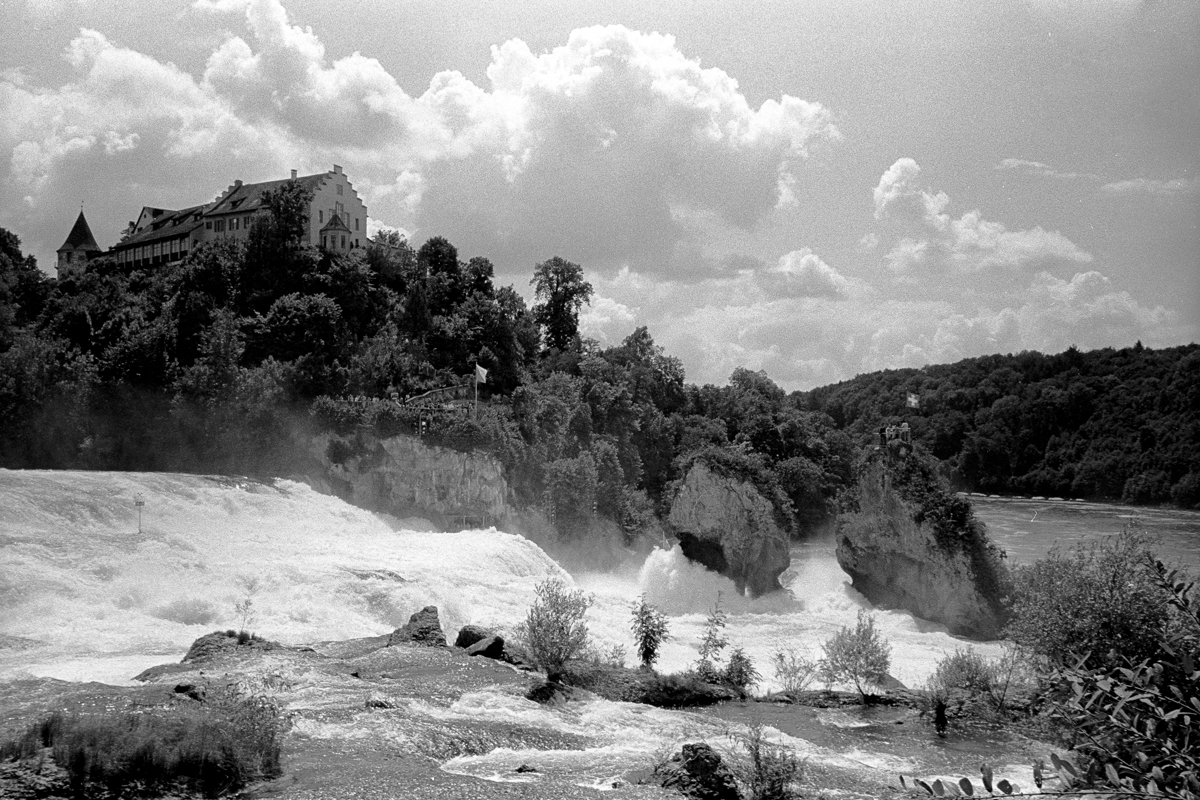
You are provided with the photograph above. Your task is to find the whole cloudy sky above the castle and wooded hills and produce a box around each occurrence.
[0,0,1200,390]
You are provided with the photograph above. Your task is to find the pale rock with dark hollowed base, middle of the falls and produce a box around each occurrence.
[668,462,791,595]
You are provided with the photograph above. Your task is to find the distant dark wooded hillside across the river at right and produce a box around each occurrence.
[800,343,1200,507]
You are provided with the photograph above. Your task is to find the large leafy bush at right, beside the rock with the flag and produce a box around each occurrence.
[1006,529,1168,667]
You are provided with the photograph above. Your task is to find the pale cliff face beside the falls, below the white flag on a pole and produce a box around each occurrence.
[310,433,509,528]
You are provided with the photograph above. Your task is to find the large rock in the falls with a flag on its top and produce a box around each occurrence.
[838,443,1009,639]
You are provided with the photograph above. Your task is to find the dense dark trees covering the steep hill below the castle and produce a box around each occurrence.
[0,184,854,536]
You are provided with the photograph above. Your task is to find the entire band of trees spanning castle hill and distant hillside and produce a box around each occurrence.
[0,184,1200,537]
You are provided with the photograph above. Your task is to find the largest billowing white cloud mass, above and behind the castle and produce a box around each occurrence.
[0,0,839,275]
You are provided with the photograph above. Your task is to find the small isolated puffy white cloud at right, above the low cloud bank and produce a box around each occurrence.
[874,158,1092,276]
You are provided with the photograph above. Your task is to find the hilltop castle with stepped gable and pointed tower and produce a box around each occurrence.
[58,164,367,278]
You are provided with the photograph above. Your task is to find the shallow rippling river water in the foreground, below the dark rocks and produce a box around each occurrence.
[0,637,1044,800]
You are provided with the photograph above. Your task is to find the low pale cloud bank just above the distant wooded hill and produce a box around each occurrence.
[596,270,1180,390]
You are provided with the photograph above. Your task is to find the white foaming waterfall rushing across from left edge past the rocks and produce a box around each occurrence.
[0,470,998,691]
